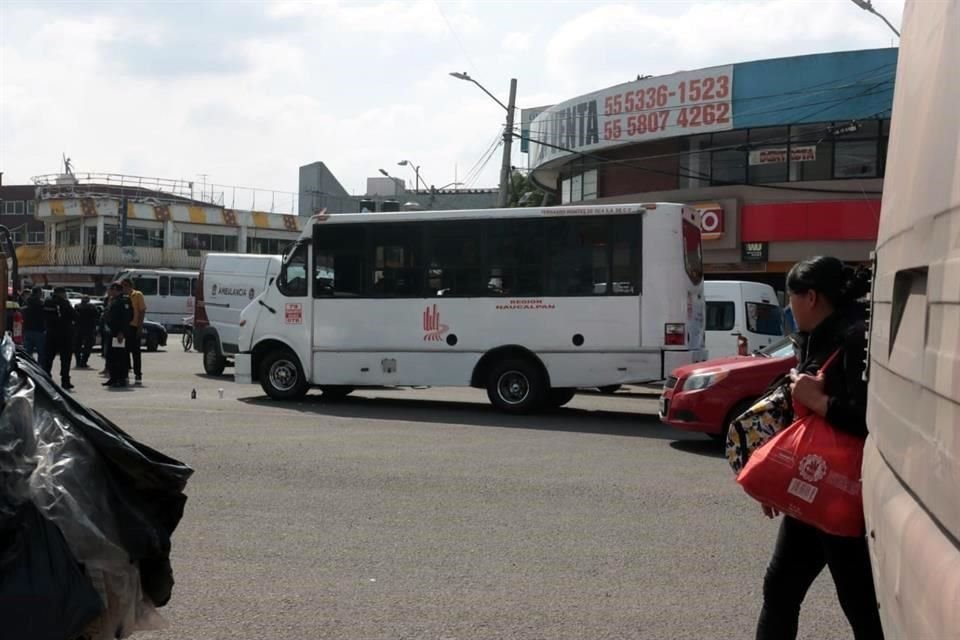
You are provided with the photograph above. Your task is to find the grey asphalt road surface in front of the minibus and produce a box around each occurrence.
[67,348,852,640]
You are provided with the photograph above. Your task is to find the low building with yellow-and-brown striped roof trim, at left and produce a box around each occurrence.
[17,174,306,293]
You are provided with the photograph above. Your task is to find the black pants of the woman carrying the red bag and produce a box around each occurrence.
[757,517,883,640]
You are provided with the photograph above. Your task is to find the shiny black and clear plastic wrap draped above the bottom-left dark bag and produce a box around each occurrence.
[0,338,193,637]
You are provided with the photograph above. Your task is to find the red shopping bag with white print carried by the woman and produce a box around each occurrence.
[737,358,864,537]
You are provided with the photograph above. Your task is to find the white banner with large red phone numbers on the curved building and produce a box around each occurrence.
[530,65,733,167]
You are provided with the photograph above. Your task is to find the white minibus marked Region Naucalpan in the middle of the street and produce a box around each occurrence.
[235,204,706,412]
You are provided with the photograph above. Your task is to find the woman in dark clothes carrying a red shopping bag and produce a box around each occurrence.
[756,257,883,640]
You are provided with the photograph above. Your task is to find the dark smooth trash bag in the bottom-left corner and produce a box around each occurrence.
[0,502,103,640]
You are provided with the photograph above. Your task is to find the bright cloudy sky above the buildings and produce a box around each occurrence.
[0,0,903,209]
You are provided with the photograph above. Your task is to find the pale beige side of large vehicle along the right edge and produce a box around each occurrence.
[863,0,960,640]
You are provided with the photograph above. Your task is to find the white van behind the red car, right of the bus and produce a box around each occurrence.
[703,280,783,358]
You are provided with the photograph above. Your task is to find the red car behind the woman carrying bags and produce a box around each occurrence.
[660,338,797,440]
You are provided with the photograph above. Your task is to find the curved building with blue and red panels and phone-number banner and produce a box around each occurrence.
[522,49,897,289]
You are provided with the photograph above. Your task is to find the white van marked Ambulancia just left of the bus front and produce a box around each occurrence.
[193,253,282,376]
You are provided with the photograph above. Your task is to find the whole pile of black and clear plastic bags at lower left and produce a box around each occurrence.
[0,336,193,640]
